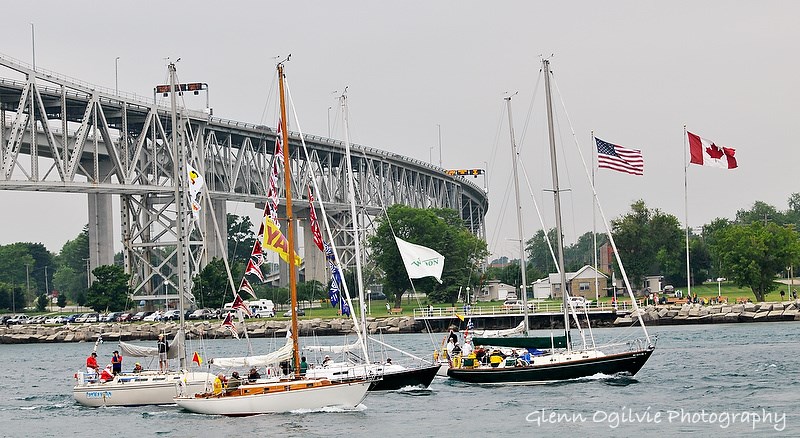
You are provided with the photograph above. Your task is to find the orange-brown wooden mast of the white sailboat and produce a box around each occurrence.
[278,63,300,378]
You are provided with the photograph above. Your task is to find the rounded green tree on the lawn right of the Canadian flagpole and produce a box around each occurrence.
[712,221,800,301]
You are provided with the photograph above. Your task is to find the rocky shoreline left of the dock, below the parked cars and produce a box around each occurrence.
[0,317,424,344]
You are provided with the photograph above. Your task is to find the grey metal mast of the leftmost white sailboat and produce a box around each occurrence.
[168,63,189,370]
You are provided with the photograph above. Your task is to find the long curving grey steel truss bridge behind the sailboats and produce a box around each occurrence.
[0,55,488,299]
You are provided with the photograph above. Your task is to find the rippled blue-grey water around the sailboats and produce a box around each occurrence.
[0,322,800,437]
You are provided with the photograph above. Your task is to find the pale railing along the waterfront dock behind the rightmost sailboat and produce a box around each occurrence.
[414,300,642,318]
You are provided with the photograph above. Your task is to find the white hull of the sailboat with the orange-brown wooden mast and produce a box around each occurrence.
[174,380,372,416]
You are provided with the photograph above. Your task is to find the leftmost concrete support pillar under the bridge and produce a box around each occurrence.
[87,193,114,276]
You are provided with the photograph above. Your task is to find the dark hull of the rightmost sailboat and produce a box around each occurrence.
[447,349,653,384]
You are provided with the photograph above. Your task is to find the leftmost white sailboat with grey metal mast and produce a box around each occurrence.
[72,64,214,407]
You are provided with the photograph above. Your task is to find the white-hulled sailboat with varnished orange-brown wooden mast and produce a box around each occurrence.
[175,63,372,416]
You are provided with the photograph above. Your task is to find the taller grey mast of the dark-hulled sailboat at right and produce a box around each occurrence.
[542,59,571,351]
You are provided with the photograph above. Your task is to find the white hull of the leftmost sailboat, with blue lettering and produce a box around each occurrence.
[72,372,214,407]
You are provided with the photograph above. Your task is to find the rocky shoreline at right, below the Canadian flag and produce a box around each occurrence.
[614,301,800,326]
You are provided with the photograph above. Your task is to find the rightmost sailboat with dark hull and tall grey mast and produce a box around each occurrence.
[447,59,655,384]
